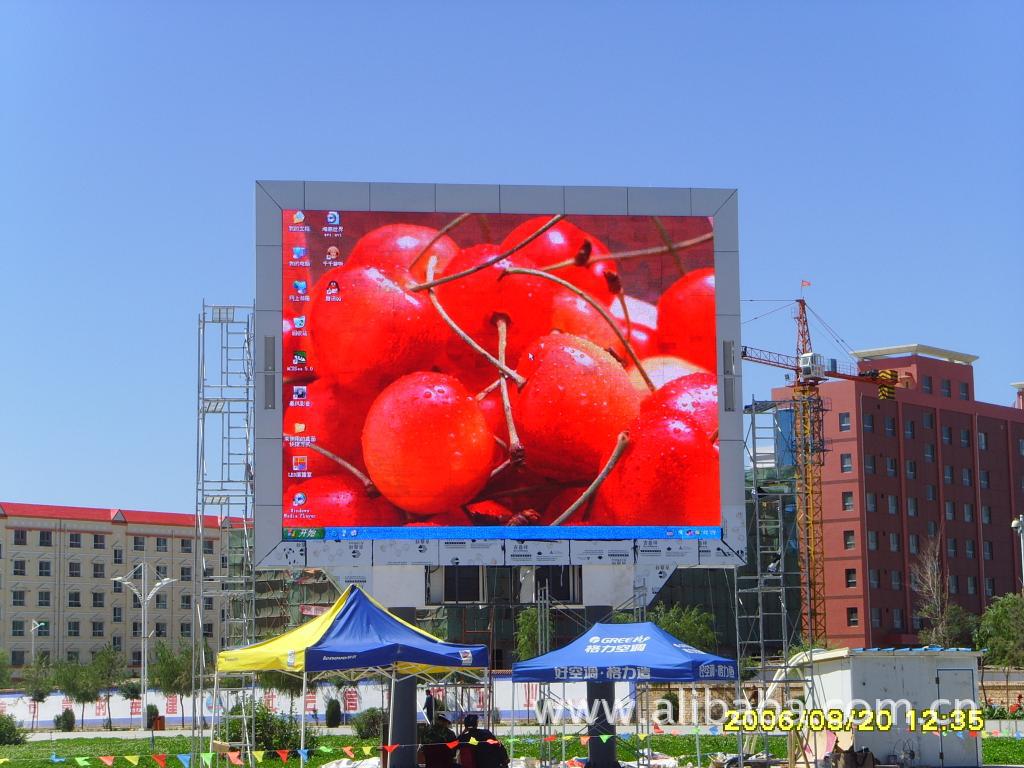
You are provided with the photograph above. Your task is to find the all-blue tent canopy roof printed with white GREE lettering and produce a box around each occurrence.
[512,622,737,683]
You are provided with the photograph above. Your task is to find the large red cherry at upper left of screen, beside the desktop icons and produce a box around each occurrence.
[309,265,450,388]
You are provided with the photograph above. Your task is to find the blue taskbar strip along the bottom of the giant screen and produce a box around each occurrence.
[284,525,722,542]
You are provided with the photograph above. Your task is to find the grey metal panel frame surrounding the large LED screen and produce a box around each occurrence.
[253,181,746,567]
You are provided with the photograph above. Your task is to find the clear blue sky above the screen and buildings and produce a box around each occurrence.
[0,0,1024,518]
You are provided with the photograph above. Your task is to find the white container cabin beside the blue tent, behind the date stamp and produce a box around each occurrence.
[793,646,981,768]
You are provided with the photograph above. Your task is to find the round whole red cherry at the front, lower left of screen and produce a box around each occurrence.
[362,372,495,514]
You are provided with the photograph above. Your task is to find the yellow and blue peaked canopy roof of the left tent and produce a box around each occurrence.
[217,585,487,675]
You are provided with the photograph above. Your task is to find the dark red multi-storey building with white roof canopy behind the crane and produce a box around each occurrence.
[773,344,1024,647]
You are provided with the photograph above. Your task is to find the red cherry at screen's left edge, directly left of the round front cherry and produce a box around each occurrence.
[283,379,376,476]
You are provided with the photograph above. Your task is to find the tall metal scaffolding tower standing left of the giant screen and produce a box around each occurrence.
[191,303,256,762]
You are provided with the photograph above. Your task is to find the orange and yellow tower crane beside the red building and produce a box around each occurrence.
[741,298,896,646]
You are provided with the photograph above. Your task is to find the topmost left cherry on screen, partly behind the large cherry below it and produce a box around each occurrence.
[345,224,459,283]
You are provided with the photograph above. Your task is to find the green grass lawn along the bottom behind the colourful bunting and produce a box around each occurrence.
[0,735,1024,768]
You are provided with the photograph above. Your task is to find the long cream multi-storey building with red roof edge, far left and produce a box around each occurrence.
[0,502,226,677]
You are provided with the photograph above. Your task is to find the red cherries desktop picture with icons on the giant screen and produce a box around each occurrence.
[282,210,721,539]
